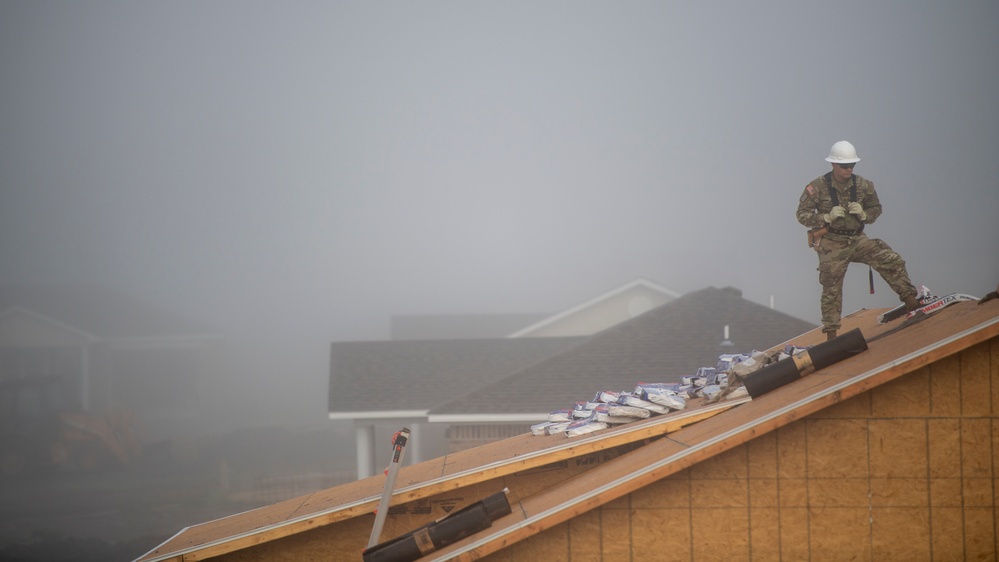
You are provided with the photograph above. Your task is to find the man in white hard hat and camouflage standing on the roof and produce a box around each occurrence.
[796,141,919,339]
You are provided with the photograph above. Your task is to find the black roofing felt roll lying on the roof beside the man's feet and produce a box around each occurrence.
[743,328,867,398]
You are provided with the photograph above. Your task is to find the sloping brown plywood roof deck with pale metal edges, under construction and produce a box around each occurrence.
[139,301,999,562]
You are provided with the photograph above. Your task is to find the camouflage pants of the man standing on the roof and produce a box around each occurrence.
[817,234,916,332]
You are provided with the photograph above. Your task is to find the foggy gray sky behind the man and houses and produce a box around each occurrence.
[0,0,999,420]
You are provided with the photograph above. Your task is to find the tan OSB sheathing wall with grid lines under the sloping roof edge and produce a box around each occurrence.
[472,330,999,562]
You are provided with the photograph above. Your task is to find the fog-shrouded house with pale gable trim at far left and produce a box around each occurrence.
[0,285,222,439]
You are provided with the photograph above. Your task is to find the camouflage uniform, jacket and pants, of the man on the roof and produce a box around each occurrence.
[796,174,916,332]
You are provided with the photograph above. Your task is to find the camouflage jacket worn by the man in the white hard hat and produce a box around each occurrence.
[795,174,881,230]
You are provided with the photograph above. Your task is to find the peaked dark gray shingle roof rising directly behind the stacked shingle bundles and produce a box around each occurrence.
[430,287,815,416]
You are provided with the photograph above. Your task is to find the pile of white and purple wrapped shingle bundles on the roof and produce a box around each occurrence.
[531,345,800,437]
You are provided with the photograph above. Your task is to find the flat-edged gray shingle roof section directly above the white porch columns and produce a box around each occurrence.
[329,338,585,414]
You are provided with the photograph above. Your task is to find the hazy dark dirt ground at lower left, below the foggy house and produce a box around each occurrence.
[0,424,353,562]
